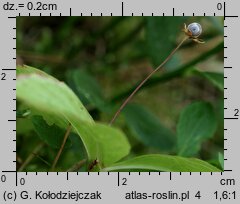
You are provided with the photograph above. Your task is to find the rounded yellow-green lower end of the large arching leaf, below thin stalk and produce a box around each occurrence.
[71,121,130,166]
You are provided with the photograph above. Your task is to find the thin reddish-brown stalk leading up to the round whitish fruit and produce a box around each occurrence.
[109,36,189,125]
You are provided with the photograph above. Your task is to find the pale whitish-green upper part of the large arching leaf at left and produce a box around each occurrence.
[17,74,93,123]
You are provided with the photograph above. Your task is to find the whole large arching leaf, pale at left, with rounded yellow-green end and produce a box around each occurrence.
[17,66,130,165]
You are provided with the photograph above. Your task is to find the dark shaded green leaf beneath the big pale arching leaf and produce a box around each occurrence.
[31,116,71,149]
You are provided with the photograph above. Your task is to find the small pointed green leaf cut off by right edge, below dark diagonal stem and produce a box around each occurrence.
[199,72,224,91]
